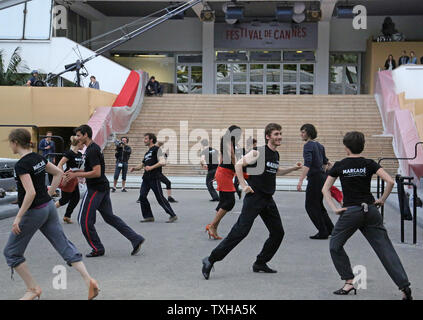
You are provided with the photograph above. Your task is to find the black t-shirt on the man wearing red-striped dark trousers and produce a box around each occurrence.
[84,142,109,191]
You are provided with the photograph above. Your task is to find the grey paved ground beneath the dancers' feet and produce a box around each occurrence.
[0,190,423,300]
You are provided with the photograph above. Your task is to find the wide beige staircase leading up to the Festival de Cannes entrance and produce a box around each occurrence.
[104,94,398,177]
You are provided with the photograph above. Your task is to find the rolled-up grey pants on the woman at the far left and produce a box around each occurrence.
[3,201,82,268]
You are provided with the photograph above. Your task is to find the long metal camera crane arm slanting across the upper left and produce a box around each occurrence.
[45,0,203,87]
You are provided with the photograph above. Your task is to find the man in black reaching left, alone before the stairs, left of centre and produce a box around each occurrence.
[131,133,178,223]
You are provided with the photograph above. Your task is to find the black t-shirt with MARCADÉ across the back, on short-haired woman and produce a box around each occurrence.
[329,157,381,207]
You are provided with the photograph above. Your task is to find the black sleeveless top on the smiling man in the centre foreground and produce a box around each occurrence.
[247,145,279,196]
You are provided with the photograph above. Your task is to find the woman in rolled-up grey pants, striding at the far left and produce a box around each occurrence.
[4,129,99,300]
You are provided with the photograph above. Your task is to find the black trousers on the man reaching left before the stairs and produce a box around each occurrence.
[139,178,175,219]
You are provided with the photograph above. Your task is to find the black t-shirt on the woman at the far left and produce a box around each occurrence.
[15,152,51,209]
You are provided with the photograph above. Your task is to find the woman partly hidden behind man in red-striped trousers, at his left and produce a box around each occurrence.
[56,136,84,224]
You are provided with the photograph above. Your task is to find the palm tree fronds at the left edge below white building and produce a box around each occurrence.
[0,47,29,86]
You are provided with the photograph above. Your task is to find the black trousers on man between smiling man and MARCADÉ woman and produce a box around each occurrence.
[305,174,333,236]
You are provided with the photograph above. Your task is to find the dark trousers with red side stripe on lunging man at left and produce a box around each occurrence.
[78,189,144,252]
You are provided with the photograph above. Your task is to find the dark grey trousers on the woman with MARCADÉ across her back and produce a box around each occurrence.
[330,205,410,289]
